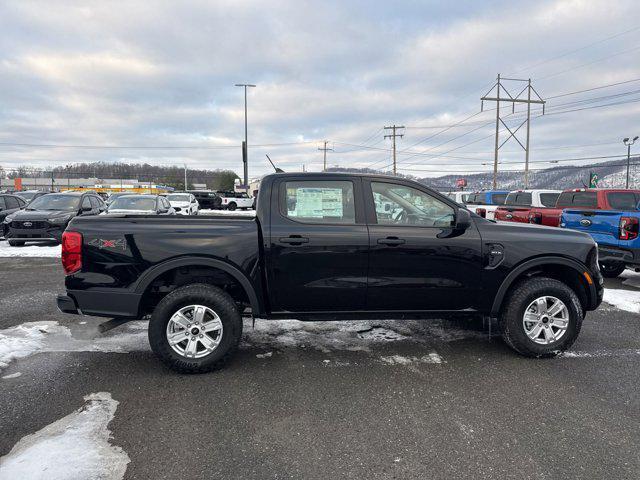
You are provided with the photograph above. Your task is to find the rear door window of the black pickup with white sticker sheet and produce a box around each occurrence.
[282,181,356,224]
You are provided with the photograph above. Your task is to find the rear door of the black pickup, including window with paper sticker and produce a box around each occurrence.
[267,174,369,312]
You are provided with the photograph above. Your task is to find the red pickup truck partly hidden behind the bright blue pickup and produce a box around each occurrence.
[529,188,640,227]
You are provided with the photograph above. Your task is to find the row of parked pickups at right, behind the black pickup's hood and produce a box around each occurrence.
[446,188,640,278]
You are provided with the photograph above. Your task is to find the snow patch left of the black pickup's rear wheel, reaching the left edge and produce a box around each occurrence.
[0,321,149,370]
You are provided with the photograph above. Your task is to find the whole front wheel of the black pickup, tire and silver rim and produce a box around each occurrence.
[500,277,583,358]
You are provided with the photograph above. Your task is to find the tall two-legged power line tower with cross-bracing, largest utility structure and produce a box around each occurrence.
[480,74,545,190]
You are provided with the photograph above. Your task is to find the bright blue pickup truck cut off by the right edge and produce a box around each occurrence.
[560,208,640,278]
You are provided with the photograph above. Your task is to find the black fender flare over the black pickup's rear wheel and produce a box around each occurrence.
[133,257,262,316]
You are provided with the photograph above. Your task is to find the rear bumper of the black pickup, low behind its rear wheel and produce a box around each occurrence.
[57,290,142,318]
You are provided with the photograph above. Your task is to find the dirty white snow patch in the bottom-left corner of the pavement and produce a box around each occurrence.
[0,392,131,480]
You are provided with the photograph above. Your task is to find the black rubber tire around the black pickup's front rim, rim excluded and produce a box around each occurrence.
[499,277,584,358]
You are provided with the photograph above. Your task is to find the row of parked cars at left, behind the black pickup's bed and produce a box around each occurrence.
[0,191,252,246]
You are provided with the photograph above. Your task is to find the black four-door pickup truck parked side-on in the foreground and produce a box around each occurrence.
[58,173,603,372]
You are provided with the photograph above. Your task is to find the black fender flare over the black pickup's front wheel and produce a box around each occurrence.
[491,256,597,317]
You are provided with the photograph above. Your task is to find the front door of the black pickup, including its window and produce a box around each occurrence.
[364,179,482,311]
